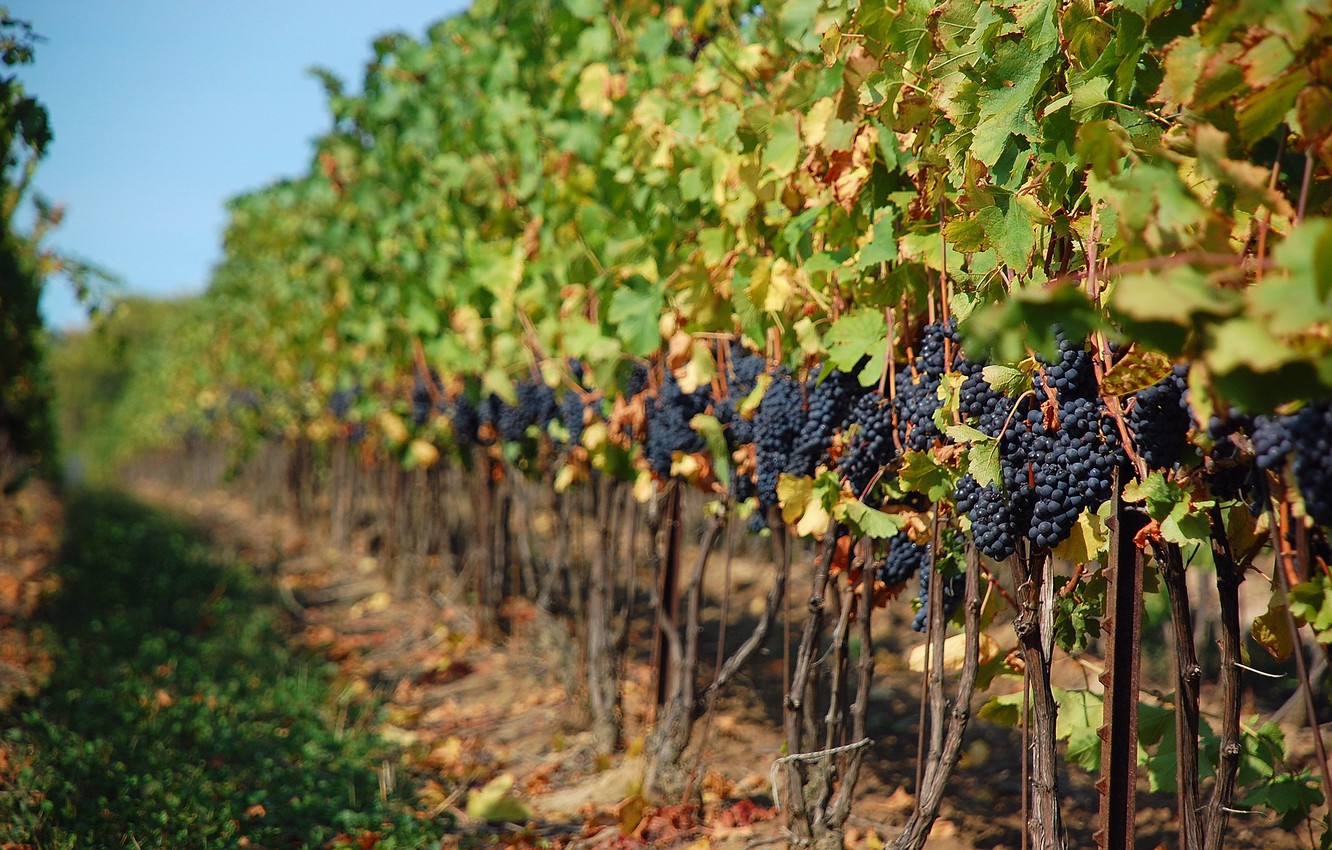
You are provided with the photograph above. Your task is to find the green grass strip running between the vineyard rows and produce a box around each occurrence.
[0,494,446,849]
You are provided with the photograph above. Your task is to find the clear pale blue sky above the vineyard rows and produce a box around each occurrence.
[9,0,468,328]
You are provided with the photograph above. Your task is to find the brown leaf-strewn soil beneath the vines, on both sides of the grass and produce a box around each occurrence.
[0,485,1308,850]
